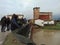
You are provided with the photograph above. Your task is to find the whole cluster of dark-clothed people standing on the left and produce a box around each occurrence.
[1,14,26,32]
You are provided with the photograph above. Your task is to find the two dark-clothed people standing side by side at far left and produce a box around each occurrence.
[1,16,10,32]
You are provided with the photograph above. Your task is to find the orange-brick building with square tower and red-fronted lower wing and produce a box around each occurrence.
[33,7,52,20]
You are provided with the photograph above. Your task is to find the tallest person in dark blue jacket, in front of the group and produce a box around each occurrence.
[11,14,20,31]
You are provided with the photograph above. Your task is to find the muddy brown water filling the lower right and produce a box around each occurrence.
[33,30,60,45]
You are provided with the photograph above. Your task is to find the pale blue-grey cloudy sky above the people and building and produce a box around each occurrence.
[0,0,60,19]
